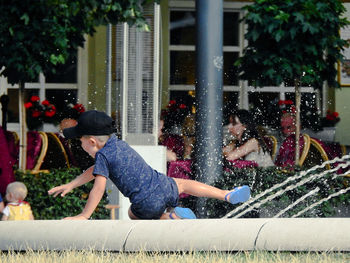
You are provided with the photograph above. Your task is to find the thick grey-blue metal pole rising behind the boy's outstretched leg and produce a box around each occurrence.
[195,0,223,198]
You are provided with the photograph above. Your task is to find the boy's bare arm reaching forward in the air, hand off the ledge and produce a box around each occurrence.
[48,166,95,197]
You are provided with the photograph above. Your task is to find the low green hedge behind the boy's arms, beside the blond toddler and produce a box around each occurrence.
[16,168,109,220]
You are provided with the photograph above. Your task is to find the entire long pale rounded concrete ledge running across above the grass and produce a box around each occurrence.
[0,218,350,252]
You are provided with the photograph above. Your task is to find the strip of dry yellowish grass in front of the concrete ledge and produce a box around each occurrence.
[0,250,350,263]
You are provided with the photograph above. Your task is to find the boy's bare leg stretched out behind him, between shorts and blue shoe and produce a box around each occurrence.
[173,178,230,200]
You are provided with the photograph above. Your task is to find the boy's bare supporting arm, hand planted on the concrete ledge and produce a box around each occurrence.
[65,175,107,220]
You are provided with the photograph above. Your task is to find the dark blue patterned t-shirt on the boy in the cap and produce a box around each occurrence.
[93,135,167,204]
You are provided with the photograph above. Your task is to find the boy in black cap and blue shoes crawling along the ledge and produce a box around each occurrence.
[48,110,250,219]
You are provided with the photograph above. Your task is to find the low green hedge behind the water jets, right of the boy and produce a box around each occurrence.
[205,167,350,218]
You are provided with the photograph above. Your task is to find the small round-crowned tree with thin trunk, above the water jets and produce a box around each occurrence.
[235,0,349,163]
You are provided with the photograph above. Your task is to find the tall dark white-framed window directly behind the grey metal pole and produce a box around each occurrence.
[168,1,242,117]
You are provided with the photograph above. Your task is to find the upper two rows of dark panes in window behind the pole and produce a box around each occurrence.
[169,9,241,86]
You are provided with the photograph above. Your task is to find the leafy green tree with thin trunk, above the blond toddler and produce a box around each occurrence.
[0,0,157,169]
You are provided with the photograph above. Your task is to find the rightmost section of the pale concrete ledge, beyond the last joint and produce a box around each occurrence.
[256,218,350,251]
